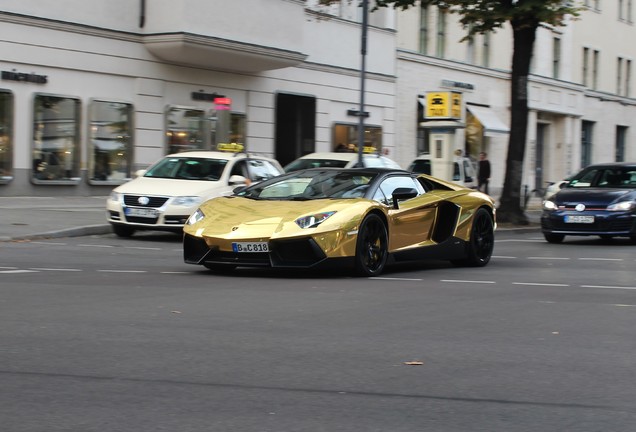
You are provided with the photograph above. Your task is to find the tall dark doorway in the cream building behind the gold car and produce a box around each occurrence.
[274,93,316,166]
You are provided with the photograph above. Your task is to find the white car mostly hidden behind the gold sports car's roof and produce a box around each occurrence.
[285,152,402,172]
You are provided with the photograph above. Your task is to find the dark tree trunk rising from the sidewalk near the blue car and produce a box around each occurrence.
[497,21,538,225]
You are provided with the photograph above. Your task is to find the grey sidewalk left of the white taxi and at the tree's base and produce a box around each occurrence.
[0,196,541,242]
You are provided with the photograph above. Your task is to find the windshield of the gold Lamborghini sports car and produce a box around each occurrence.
[236,170,377,201]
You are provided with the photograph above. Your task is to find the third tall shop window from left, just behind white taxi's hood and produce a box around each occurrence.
[88,100,133,183]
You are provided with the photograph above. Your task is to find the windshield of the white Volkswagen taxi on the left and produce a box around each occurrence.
[144,157,227,181]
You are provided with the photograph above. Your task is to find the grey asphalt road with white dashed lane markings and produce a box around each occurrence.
[0,233,636,432]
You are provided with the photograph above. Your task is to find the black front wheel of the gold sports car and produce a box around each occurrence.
[355,214,389,276]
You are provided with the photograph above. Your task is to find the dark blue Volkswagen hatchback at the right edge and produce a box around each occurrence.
[541,163,636,243]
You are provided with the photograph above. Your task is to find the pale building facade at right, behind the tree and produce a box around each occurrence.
[396,0,636,196]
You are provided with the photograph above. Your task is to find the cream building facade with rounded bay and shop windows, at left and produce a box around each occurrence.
[0,0,396,196]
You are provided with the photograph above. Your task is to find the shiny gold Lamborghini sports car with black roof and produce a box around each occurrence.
[183,168,496,276]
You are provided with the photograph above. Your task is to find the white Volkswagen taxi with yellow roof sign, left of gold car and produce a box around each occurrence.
[106,151,283,237]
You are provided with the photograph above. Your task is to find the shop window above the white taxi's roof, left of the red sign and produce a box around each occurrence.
[166,107,205,154]
